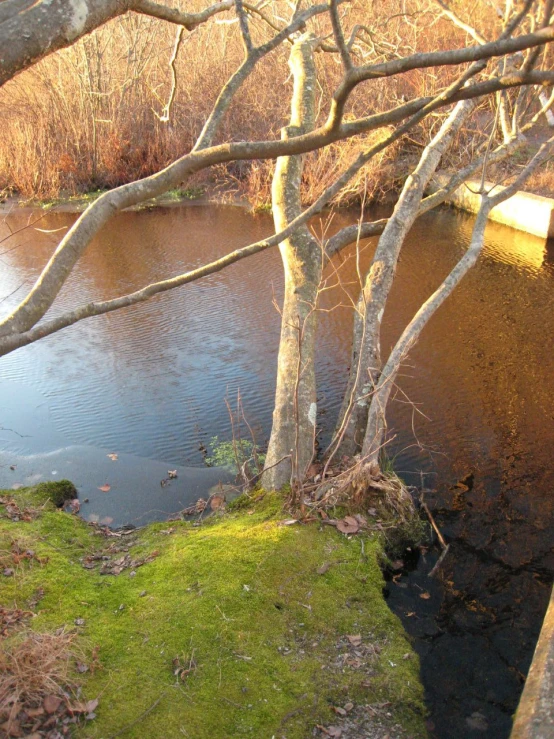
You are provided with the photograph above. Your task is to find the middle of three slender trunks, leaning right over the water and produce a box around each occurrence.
[335,101,473,456]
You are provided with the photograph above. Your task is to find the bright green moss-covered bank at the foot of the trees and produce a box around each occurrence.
[0,488,425,739]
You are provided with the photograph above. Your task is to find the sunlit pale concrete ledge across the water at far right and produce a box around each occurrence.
[433,174,554,239]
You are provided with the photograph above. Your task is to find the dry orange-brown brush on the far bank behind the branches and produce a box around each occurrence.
[0,0,504,206]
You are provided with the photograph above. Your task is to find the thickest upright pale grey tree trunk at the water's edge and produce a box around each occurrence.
[262,35,322,489]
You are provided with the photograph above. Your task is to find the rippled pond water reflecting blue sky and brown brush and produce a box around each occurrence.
[0,199,554,739]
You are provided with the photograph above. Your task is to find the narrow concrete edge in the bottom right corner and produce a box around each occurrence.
[510,591,554,739]
